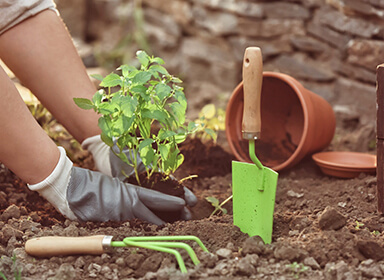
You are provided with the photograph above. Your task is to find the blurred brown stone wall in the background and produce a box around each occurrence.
[58,0,384,125]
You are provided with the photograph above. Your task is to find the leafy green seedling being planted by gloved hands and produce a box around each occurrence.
[74,51,196,184]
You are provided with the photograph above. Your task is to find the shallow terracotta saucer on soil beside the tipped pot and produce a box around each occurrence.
[312,152,376,178]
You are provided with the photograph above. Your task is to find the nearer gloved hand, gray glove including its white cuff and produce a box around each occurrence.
[28,147,190,225]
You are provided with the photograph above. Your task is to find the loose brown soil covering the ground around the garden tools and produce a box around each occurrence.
[0,123,384,279]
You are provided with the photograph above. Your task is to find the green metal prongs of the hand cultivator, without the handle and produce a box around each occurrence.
[111,235,208,273]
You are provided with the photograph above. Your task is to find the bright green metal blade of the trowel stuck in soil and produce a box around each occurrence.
[232,161,278,244]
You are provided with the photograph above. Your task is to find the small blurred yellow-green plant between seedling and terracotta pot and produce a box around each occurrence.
[192,104,225,142]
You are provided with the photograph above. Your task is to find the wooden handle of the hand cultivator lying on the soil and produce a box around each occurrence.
[25,235,109,257]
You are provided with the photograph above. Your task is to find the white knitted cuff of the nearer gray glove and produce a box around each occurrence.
[28,147,77,220]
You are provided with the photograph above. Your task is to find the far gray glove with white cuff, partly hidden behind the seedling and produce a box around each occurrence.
[81,135,197,211]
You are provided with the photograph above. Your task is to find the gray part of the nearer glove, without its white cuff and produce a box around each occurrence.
[67,167,185,225]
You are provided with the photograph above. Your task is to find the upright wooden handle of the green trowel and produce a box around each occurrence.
[242,47,263,140]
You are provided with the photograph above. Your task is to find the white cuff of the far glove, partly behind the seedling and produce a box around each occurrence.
[81,135,112,176]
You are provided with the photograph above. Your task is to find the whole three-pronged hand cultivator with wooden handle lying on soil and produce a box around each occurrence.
[25,235,208,273]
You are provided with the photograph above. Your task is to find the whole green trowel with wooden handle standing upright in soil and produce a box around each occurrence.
[232,47,278,243]
